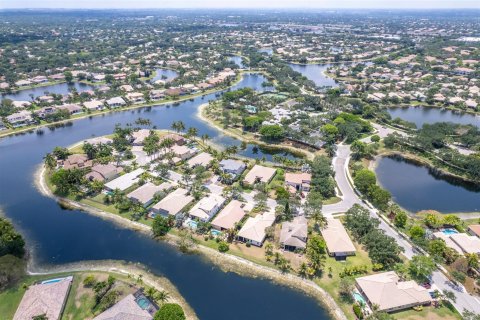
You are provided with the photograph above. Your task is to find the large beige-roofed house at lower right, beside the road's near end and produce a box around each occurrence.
[355,271,431,312]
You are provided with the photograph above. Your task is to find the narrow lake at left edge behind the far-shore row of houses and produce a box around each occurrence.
[2,82,95,101]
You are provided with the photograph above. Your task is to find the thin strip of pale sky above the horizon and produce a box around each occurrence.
[0,0,480,8]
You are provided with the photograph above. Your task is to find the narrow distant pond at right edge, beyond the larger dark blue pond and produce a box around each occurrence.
[388,107,480,128]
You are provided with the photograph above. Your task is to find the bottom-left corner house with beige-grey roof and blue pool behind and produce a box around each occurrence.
[13,277,73,320]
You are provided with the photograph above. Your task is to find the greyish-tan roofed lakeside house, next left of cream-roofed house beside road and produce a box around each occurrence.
[280,216,308,251]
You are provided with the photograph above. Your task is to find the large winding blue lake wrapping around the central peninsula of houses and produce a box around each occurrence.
[0,75,330,320]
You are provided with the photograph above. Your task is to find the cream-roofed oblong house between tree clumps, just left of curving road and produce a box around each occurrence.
[321,219,357,257]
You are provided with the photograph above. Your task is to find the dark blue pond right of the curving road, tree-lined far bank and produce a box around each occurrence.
[376,157,480,213]
